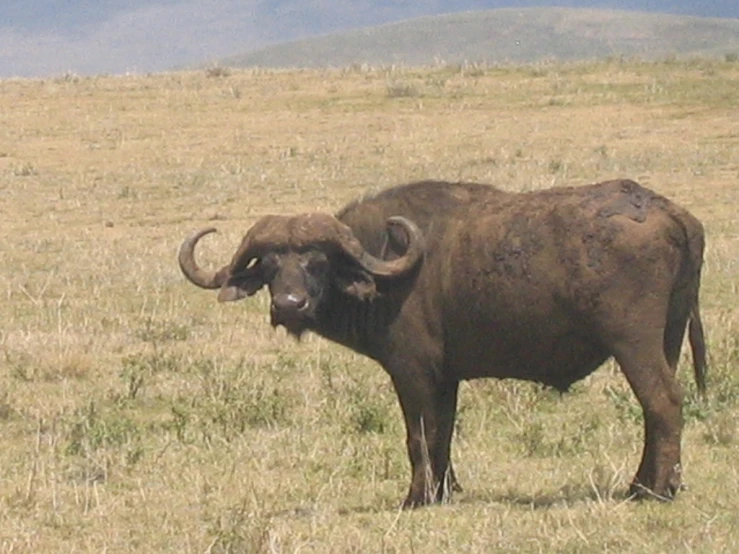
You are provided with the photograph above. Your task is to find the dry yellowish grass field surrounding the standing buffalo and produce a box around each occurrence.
[0,60,739,554]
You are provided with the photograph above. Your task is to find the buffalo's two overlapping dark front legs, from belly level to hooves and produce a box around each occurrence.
[393,379,458,508]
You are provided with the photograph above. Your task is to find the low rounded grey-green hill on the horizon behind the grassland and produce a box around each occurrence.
[219,8,739,67]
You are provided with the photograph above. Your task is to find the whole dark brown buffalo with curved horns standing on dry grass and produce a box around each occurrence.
[179,180,706,507]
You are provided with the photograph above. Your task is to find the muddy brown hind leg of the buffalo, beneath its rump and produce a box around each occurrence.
[616,337,683,500]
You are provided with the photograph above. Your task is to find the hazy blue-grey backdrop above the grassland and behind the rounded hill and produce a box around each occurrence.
[0,0,739,78]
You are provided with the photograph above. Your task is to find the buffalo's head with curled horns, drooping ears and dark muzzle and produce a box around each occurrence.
[178,213,425,336]
